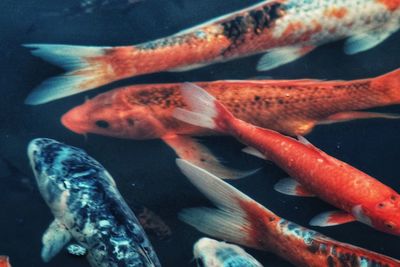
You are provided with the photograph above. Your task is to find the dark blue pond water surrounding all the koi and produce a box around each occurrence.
[0,0,400,267]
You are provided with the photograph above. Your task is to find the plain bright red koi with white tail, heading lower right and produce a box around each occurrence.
[174,84,400,235]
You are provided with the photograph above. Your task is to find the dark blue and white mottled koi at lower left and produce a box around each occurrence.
[28,138,161,267]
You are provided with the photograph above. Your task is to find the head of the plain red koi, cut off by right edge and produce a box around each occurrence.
[353,197,400,236]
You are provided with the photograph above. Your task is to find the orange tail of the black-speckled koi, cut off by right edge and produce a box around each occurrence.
[372,68,400,104]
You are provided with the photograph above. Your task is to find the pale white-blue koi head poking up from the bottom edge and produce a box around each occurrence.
[193,237,262,267]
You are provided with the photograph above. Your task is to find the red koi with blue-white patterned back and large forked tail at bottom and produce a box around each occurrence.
[177,159,400,267]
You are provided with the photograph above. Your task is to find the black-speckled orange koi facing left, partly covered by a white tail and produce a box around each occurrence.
[61,69,400,178]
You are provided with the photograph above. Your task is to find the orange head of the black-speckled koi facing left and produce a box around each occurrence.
[61,93,163,140]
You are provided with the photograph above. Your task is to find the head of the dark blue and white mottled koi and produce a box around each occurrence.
[28,138,107,217]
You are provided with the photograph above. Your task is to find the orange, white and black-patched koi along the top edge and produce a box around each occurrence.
[25,0,400,105]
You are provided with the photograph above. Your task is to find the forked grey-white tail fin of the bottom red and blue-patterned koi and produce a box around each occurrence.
[177,159,277,249]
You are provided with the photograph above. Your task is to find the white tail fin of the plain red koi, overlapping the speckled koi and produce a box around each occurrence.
[174,83,235,133]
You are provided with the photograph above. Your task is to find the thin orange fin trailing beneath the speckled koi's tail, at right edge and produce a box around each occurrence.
[318,111,400,124]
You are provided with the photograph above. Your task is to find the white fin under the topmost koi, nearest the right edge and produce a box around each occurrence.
[344,29,392,55]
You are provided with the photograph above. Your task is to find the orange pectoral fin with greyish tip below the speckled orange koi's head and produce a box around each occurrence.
[162,135,257,179]
